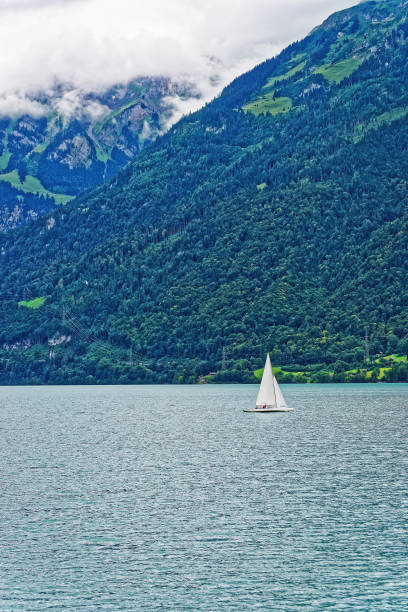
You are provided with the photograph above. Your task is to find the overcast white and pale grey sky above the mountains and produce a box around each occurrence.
[0,0,357,115]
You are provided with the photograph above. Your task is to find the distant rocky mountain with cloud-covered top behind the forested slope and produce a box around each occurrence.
[0,78,194,231]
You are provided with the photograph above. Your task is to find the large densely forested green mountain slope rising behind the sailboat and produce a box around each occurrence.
[0,0,408,383]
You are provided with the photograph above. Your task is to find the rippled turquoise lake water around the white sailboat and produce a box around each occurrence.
[0,385,408,612]
